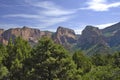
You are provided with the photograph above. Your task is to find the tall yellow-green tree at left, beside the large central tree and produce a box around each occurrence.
[5,37,31,80]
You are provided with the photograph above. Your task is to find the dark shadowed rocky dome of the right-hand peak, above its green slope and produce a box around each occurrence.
[78,26,107,49]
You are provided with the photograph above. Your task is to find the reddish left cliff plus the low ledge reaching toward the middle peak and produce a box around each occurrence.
[1,26,52,44]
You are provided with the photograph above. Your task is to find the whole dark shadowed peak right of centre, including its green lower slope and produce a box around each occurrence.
[77,26,109,55]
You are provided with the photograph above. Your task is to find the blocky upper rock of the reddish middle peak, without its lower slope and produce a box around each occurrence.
[54,27,76,44]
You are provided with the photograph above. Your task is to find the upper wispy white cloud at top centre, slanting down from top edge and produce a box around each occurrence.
[26,0,76,16]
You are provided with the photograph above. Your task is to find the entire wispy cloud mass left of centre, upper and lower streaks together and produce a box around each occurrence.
[3,0,76,28]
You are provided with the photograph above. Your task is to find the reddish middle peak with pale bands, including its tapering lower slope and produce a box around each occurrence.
[53,27,77,50]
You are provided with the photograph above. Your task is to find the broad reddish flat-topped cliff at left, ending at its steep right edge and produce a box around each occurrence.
[2,27,40,42]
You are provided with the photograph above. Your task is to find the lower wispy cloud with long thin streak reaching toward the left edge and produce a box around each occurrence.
[3,14,72,28]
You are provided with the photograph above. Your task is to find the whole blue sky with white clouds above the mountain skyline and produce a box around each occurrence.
[0,0,120,34]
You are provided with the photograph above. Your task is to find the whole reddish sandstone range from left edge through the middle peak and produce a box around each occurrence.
[0,26,76,48]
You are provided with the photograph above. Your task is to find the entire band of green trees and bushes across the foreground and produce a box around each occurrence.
[0,37,120,80]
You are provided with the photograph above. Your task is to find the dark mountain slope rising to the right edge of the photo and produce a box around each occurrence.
[101,22,120,51]
